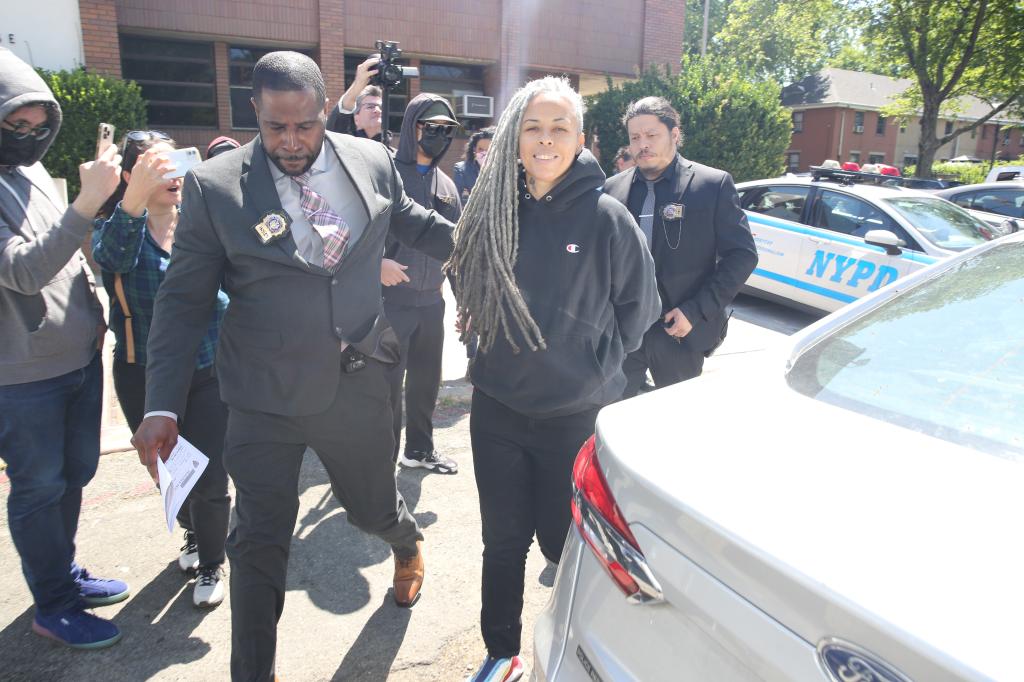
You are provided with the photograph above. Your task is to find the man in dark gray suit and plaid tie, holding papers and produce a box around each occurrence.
[135,52,453,681]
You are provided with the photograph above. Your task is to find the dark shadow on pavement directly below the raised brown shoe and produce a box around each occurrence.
[331,592,413,682]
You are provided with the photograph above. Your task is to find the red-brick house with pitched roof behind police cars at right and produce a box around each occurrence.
[782,69,1024,171]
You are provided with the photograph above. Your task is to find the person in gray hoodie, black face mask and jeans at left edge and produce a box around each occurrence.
[0,47,128,649]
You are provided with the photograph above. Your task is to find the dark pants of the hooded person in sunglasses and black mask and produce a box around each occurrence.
[384,300,444,454]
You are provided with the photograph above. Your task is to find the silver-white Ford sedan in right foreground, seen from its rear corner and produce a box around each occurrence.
[534,235,1024,682]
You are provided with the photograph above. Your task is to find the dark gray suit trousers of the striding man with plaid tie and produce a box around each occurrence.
[224,358,423,682]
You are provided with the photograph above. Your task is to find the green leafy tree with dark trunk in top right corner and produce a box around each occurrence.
[867,0,1024,177]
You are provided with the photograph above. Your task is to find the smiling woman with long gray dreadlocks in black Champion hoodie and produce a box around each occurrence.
[449,77,660,682]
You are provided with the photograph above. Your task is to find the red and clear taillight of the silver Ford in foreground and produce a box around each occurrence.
[572,436,663,603]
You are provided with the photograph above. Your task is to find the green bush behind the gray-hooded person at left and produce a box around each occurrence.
[39,69,146,201]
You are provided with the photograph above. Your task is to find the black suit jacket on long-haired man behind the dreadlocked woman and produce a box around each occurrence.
[604,154,758,353]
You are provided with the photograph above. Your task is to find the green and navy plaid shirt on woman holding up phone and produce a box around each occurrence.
[92,204,227,370]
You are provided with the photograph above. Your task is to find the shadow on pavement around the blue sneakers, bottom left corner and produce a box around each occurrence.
[0,560,210,680]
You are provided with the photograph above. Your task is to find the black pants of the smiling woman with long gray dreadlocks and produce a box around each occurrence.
[469,390,598,657]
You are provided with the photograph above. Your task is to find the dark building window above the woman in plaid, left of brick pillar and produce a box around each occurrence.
[121,36,217,128]
